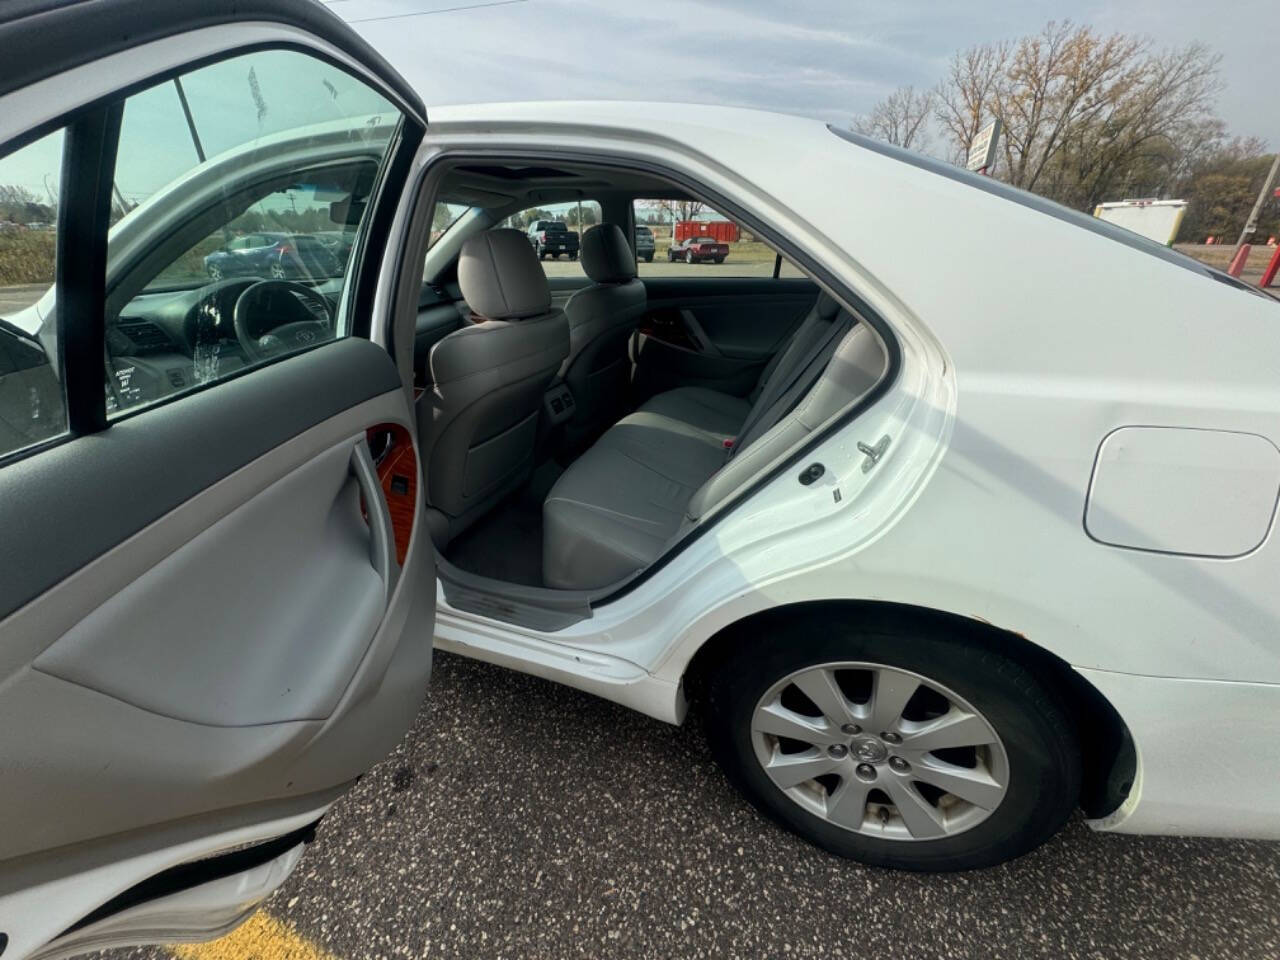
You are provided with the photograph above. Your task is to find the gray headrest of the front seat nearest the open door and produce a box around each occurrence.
[458,229,552,320]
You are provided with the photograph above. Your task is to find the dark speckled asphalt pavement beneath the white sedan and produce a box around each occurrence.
[109,654,1280,960]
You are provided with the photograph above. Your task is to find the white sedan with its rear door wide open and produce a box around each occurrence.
[0,0,1280,960]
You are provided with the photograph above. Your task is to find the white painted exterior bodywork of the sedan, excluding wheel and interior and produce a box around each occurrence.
[0,3,1280,957]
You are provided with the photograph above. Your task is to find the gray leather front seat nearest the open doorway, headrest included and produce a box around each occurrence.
[417,229,568,548]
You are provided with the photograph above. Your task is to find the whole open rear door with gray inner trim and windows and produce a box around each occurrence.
[0,0,435,960]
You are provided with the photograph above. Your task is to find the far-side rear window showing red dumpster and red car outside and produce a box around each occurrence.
[634,200,804,276]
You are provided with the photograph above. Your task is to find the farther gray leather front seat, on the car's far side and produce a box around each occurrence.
[562,223,645,447]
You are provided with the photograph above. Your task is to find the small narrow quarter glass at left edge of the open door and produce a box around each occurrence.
[0,131,67,457]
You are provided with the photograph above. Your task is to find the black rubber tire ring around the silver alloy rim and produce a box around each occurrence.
[705,614,1080,870]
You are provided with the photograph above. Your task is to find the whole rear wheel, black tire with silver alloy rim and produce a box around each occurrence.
[705,614,1080,870]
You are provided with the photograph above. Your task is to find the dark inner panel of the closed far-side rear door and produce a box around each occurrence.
[632,276,818,401]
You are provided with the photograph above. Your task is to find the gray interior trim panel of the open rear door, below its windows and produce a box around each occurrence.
[0,340,435,861]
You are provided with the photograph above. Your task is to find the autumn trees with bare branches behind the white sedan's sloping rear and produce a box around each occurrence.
[852,20,1280,242]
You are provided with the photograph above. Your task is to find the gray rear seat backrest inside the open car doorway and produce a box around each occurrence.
[681,320,886,522]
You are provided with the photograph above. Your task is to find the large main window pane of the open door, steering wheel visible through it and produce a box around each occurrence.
[105,50,401,416]
